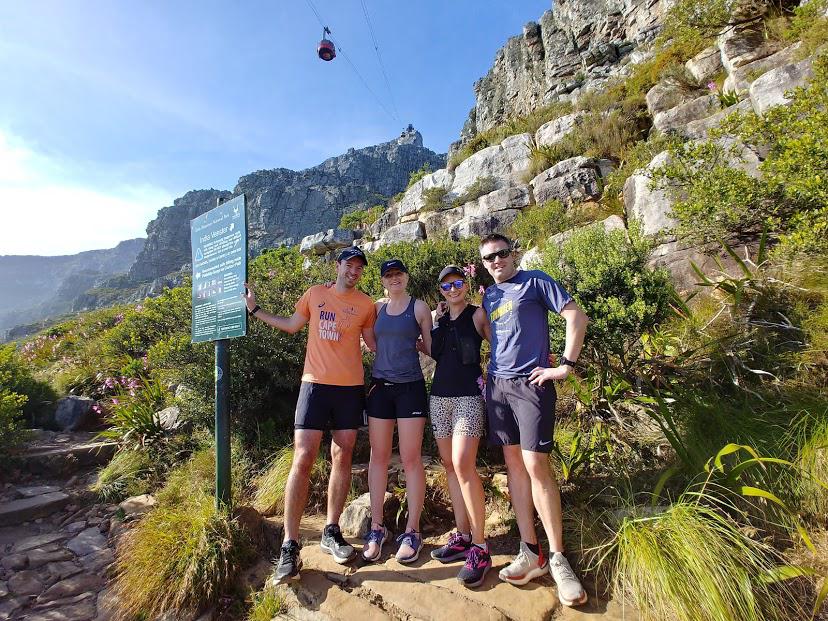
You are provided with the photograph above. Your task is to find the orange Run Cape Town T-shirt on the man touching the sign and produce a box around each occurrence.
[296,285,376,386]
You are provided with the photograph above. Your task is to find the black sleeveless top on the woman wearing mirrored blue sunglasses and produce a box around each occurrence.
[431,304,483,397]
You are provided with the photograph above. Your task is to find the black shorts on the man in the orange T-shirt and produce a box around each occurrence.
[294,382,368,430]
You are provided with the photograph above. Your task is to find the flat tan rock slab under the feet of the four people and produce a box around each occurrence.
[260,517,637,621]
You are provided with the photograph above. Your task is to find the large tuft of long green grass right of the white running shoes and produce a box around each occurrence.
[605,497,805,621]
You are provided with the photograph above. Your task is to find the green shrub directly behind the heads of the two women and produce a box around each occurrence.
[362,237,491,308]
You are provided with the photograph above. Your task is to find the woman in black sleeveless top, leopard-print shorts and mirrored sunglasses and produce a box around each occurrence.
[430,265,492,587]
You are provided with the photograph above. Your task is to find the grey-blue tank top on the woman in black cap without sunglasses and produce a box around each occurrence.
[372,297,423,383]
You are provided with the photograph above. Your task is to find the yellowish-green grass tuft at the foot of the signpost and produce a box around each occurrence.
[114,494,250,619]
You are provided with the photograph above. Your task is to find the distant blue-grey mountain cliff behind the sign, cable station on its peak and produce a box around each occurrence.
[129,131,445,283]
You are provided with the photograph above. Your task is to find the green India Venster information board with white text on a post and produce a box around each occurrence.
[190,194,247,343]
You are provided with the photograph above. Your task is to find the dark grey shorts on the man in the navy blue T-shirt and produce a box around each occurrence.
[486,375,557,453]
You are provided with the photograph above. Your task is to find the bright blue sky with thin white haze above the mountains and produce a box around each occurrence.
[0,0,551,255]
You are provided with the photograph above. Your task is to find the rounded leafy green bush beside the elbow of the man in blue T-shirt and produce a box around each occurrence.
[541,224,675,362]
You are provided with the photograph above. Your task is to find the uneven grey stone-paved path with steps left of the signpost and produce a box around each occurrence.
[0,432,122,621]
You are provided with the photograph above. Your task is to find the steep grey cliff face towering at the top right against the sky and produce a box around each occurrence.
[450,0,666,153]
